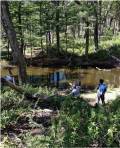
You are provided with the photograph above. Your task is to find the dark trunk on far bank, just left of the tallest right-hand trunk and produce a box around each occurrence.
[85,21,89,60]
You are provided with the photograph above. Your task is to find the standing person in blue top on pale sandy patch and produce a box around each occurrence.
[97,79,107,104]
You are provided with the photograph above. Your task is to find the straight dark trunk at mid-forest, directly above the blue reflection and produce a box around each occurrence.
[56,1,60,52]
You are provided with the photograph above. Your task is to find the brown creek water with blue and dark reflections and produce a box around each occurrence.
[1,67,120,89]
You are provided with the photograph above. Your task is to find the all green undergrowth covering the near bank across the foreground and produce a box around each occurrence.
[1,86,120,148]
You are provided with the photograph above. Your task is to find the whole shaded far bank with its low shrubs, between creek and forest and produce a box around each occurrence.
[26,46,120,69]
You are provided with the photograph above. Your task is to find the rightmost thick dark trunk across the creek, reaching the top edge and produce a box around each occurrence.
[94,1,99,51]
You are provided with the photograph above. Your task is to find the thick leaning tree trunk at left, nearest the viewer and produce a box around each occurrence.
[1,1,26,82]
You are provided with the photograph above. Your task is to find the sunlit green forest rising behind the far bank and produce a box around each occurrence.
[1,0,120,66]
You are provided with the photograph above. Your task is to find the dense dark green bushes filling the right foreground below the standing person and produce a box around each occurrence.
[48,98,120,147]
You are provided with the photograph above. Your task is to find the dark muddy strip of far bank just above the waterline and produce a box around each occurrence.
[26,55,120,69]
